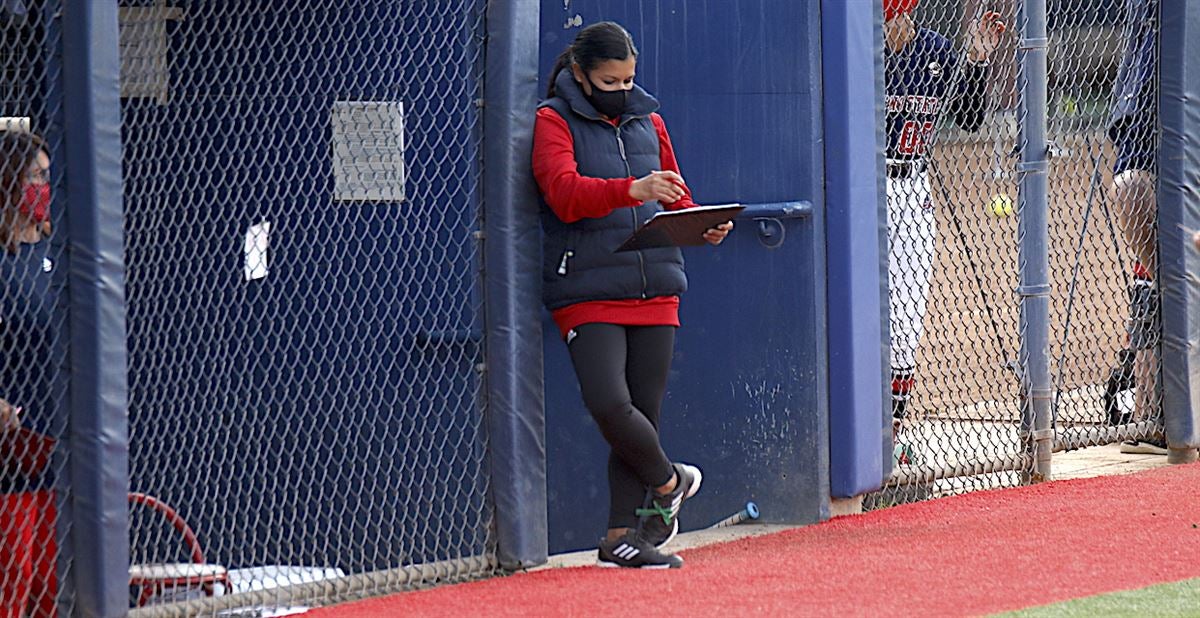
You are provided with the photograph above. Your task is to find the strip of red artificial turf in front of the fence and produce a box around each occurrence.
[312,464,1200,617]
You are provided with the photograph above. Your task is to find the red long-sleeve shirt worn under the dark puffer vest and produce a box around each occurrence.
[533,108,695,338]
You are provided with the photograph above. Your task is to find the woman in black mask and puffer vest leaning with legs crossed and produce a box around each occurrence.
[533,22,733,569]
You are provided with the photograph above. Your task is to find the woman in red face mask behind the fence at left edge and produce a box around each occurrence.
[0,131,58,618]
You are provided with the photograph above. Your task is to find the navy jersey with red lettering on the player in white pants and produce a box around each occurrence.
[883,28,988,161]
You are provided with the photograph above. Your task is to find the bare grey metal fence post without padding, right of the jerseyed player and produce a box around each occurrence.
[1018,0,1054,481]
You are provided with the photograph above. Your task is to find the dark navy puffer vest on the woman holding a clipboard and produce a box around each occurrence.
[539,70,688,310]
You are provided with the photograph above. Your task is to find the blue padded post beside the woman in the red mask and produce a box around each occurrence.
[62,1,130,617]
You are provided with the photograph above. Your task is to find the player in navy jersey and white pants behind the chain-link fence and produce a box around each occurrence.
[882,0,1006,464]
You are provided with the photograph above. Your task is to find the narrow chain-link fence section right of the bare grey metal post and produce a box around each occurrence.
[1049,0,1165,454]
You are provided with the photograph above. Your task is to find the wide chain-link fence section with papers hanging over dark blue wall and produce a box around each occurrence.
[120,0,494,613]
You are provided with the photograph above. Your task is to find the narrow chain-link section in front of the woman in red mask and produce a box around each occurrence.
[0,2,73,617]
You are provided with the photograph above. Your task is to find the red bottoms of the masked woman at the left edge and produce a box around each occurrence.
[0,491,58,618]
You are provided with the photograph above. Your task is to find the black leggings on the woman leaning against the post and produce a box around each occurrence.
[568,324,676,528]
